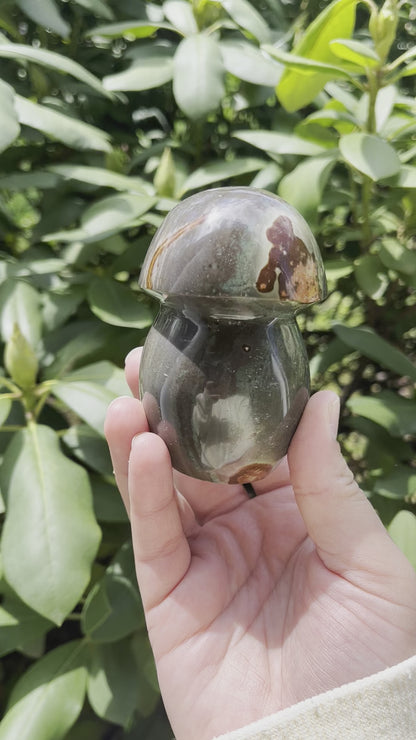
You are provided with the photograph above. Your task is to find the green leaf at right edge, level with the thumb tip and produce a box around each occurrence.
[347,391,416,437]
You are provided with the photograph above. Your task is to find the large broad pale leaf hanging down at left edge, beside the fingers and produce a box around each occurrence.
[0,423,100,624]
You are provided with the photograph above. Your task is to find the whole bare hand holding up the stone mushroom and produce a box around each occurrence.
[106,350,416,740]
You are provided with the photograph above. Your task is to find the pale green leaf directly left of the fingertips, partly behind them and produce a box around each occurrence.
[51,361,129,435]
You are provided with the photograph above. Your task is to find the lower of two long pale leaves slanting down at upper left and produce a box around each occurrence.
[15,95,111,152]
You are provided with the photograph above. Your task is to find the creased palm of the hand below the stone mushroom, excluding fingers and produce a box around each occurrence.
[148,474,410,740]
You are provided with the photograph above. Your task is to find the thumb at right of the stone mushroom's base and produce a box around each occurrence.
[288,391,399,582]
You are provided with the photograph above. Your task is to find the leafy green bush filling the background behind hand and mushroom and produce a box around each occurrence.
[0,0,416,740]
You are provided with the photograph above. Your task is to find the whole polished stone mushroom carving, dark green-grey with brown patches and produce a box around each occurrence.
[140,187,326,484]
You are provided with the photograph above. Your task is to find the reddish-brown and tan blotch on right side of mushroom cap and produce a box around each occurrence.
[256,216,319,303]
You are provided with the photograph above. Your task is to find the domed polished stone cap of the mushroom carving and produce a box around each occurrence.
[139,187,326,310]
